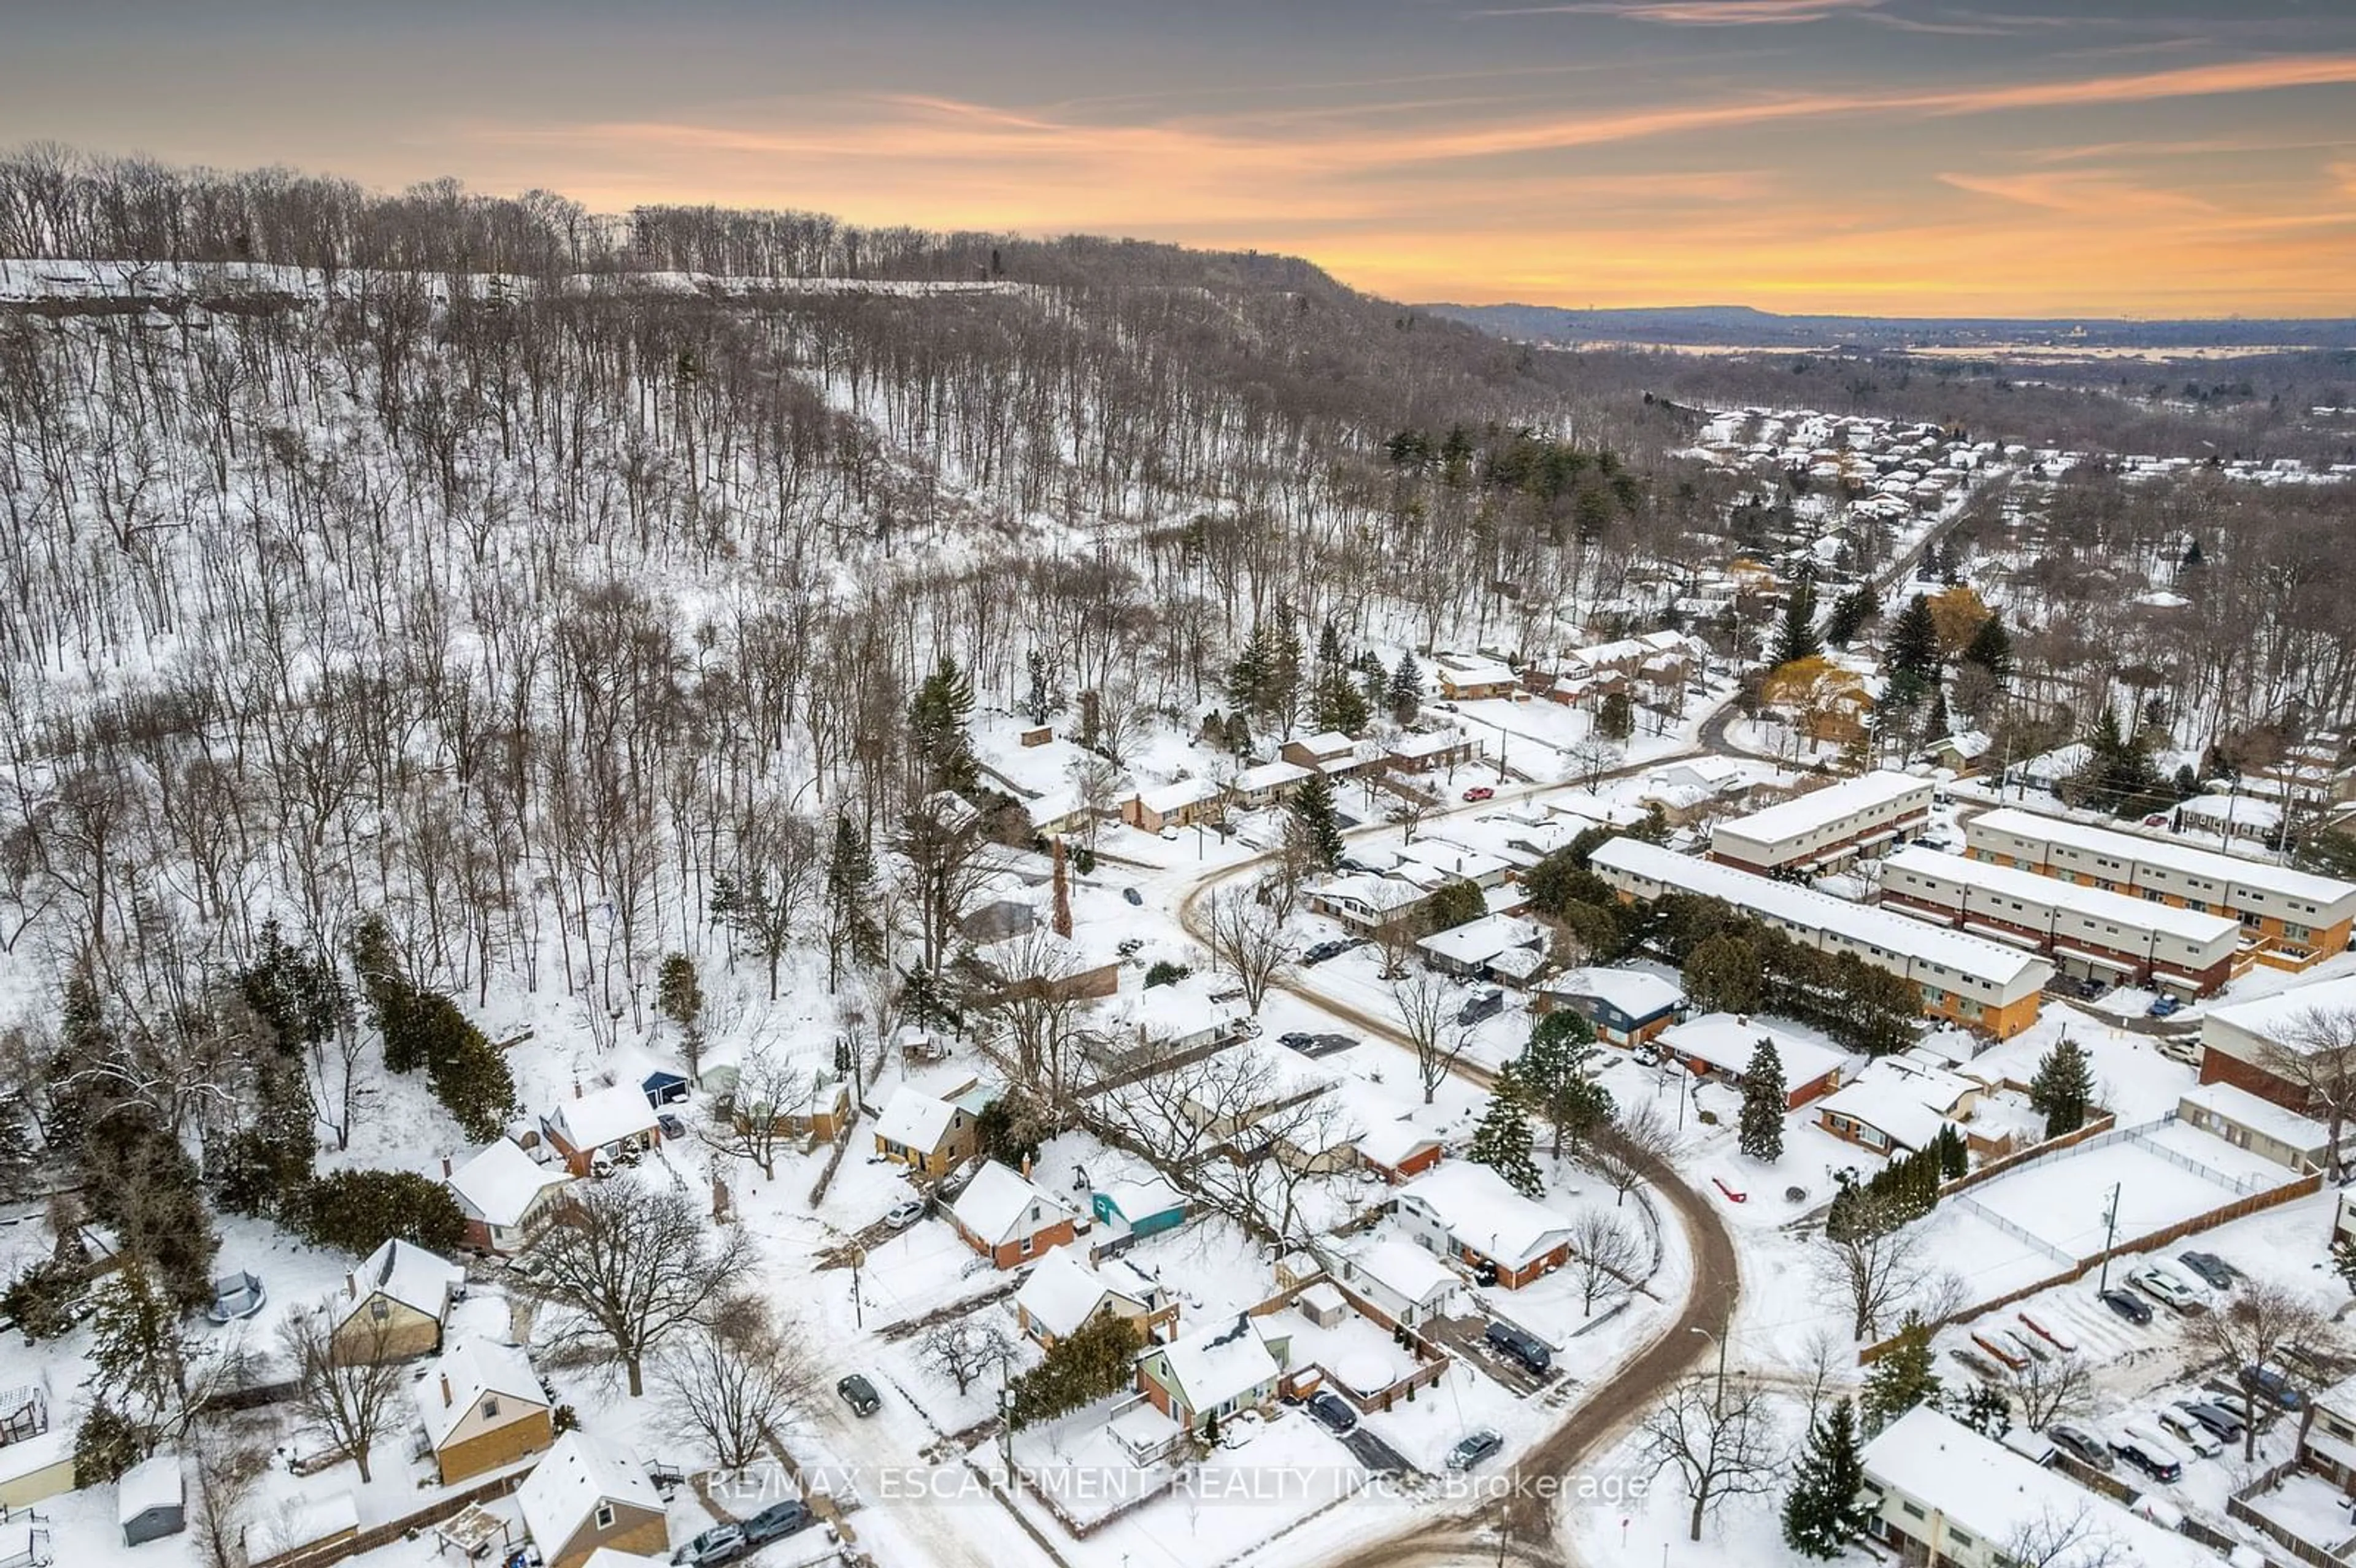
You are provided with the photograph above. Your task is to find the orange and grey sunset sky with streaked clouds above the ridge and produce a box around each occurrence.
[0,0,2356,315]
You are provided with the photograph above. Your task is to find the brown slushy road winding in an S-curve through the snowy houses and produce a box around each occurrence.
[1178,767,1741,1568]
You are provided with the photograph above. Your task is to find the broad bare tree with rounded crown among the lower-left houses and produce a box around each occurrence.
[528,1177,752,1399]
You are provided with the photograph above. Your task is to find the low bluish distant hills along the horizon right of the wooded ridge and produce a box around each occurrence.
[1419,304,2356,351]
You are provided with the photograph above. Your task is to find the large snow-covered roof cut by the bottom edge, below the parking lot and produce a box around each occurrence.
[1863,1405,2217,1568]
